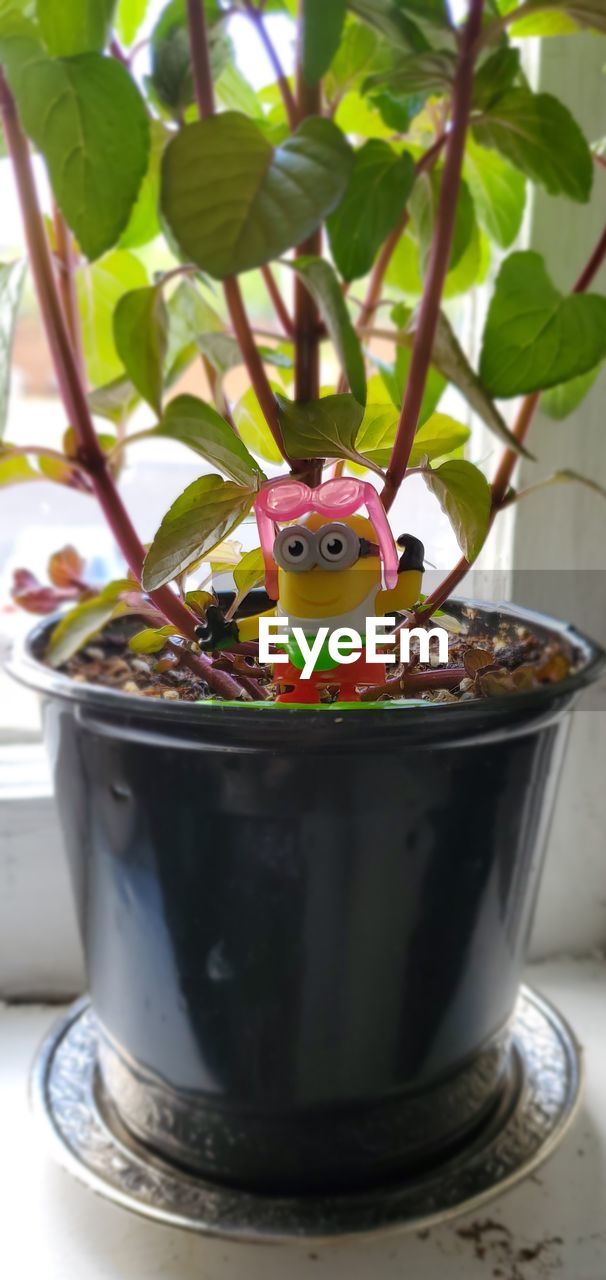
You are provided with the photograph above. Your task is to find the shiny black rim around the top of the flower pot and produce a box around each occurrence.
[5,596,606,749]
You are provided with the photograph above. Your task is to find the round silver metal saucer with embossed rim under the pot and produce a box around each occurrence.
[32,987,582,1243]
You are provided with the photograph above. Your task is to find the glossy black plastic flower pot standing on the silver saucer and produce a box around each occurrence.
[12,593,602,1193]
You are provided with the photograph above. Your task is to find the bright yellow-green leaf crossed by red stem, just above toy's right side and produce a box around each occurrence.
[356,404,470,467]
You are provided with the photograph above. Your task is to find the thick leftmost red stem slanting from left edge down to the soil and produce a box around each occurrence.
[0,72,248,698]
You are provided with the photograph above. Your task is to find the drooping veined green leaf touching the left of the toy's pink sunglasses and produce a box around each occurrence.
[142,475,255,591]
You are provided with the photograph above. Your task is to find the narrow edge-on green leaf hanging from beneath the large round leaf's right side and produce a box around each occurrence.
[288,255,366,404]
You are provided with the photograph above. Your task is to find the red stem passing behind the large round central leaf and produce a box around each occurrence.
[187,0,299,470]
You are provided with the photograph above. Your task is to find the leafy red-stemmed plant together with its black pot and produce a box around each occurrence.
[0,0,606,1190]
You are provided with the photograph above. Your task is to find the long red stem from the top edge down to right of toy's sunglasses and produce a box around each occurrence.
[382,0,484,511]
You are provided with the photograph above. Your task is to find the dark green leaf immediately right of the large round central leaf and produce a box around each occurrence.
[323,142,415,280]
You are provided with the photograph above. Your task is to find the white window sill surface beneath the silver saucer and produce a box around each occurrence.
[0,960,606,1280]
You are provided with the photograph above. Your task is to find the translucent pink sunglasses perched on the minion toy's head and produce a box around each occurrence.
[255,476,398,600]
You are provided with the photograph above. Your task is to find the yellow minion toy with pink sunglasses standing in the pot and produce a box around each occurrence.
[199,476,424,704]
